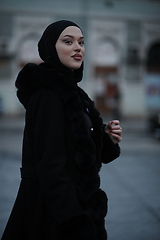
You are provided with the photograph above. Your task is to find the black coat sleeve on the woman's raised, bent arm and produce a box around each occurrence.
[101,129,120,163]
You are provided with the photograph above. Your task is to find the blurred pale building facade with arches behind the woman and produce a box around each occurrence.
[0,0,160,117]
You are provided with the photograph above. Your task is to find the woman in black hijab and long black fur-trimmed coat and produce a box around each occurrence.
[2,20,121,240]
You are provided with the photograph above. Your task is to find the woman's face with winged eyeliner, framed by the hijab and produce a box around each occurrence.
[56,26,85,70]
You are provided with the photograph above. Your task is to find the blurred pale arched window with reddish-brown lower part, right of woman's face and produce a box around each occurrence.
[93,37,120,118]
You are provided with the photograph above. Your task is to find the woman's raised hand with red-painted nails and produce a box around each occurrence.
[105,120,122,144]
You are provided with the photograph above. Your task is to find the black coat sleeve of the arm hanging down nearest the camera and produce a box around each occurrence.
[29,89,95,240]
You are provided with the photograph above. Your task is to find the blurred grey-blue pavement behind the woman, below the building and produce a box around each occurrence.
[0,116,160,240]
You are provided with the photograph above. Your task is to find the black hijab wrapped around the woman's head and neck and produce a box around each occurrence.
[38,20,83,82]
